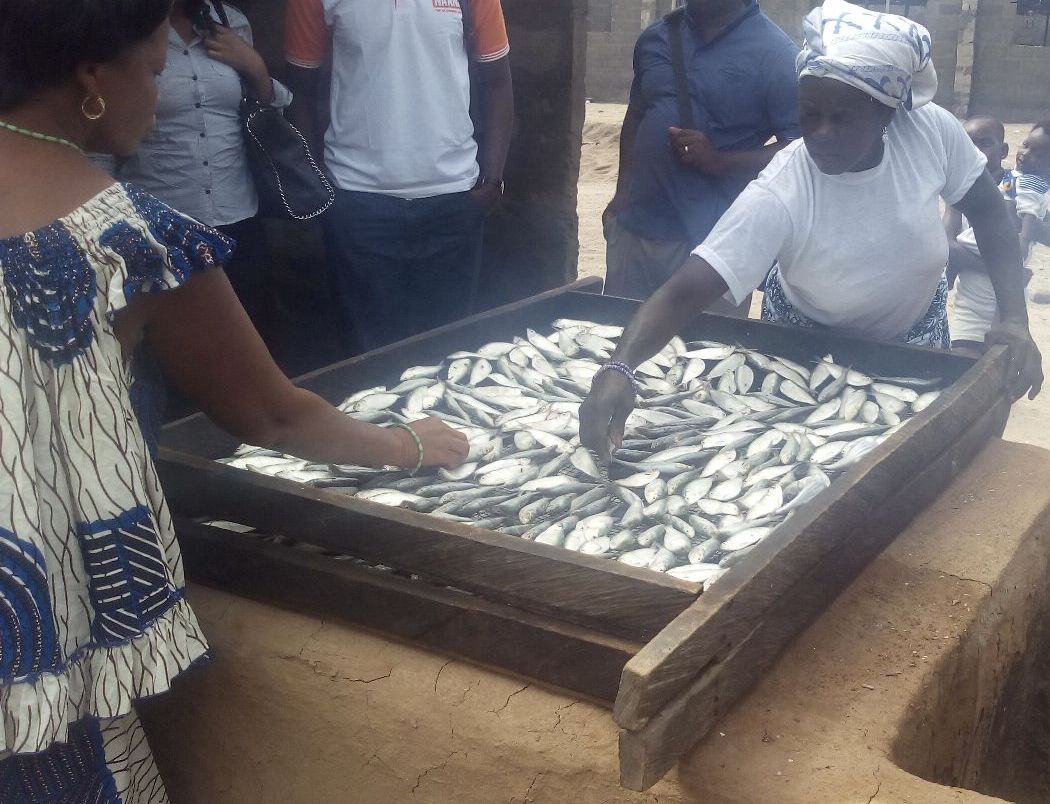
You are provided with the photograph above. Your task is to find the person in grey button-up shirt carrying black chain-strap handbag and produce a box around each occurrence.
[116,0,292,351]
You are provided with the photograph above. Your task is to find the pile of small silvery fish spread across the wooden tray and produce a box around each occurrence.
[225,319,941,584]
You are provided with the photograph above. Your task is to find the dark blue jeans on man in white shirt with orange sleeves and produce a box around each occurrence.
[324,191,484,352]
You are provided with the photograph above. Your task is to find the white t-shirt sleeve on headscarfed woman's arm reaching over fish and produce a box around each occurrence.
[693,182,792,304]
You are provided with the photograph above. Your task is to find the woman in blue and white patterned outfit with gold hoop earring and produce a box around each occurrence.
[0,0,467,804]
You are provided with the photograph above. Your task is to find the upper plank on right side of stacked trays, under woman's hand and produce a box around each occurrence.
[613,347,1007,729]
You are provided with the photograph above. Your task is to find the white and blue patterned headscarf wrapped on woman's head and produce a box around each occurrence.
[798,0,937,110]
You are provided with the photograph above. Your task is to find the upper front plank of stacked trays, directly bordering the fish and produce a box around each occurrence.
[160,453,701,641]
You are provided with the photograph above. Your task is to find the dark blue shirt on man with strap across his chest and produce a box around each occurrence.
[620,2,801,246]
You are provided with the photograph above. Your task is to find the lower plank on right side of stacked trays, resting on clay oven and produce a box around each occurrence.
[620,400,1009,790]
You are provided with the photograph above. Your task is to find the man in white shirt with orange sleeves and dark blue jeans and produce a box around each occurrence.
[286,0,513,351]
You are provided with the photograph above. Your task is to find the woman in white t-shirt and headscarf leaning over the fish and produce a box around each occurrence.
[581,0,1043,456]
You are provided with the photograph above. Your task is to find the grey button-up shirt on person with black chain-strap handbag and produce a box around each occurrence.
[117,5,292,226]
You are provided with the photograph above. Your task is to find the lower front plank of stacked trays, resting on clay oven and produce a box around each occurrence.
[176,519,642,707]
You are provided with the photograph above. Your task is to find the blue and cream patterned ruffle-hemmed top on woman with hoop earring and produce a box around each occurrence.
[0,185,230,804]
